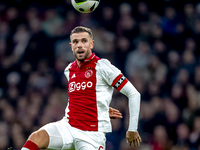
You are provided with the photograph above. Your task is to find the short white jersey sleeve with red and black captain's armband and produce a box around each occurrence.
[98,59,128,91]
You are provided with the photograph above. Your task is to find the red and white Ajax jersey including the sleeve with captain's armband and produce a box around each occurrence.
[64,53,128,132]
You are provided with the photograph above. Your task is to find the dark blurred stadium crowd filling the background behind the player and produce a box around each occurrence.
[0,0,200,150]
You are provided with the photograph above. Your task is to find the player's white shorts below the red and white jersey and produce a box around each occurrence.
[40,118,106,150]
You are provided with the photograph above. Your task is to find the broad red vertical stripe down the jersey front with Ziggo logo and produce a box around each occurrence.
[68,54,98,131]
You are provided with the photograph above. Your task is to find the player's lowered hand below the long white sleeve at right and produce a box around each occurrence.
[126,131,142,147]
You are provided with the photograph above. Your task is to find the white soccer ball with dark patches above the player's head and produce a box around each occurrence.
[71,0,100,13]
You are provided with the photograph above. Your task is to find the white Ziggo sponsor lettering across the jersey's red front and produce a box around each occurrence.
[69,81,93,92]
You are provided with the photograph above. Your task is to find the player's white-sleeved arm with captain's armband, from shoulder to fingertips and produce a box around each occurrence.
[97,59,142,146]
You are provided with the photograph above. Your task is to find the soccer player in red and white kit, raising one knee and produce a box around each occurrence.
[21,26,141,150]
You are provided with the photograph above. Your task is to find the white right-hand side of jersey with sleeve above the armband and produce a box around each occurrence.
[95,59,121,132]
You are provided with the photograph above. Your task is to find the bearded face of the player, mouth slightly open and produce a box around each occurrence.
[70,32,94,61]
